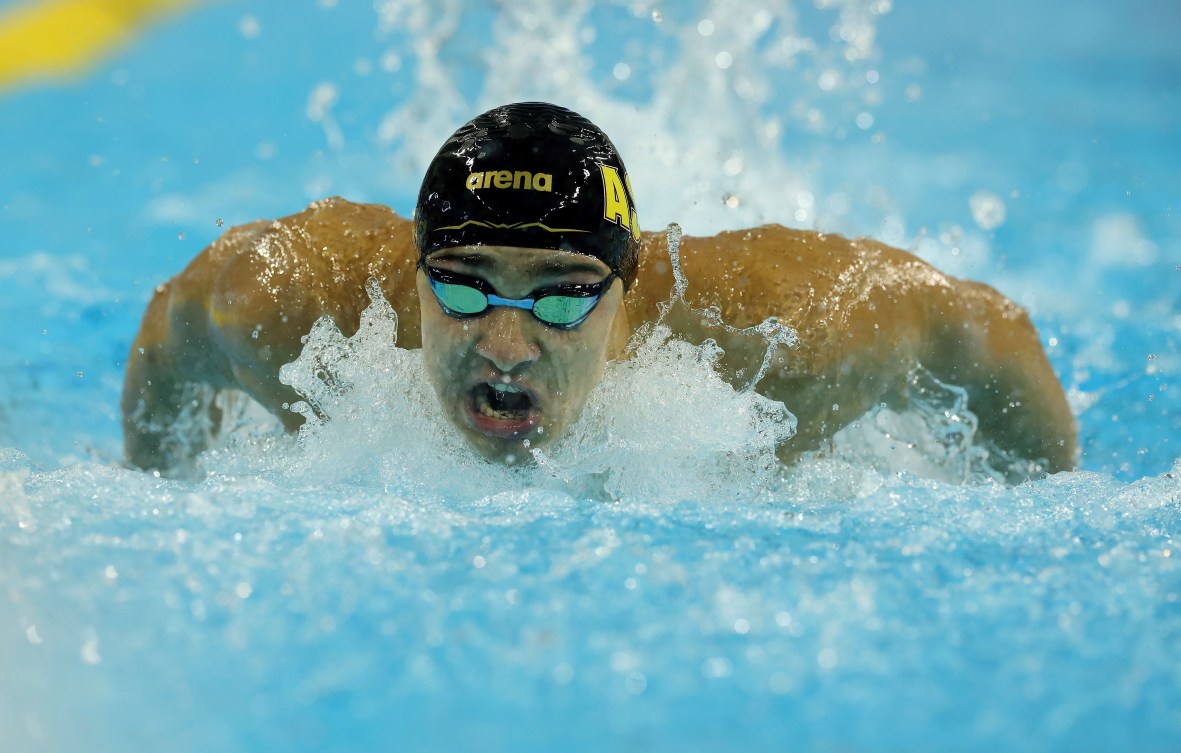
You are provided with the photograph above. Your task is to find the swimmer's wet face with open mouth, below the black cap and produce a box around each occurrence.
[417,245,627,463]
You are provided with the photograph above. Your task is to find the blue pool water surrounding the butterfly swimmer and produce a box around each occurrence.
[0,0,1181,752]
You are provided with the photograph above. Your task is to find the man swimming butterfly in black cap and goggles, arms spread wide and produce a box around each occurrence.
[123,103,1077,472]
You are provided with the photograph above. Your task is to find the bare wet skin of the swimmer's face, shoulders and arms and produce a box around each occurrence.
[123,198,1078,472]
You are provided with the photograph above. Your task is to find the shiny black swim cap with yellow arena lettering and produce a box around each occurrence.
[415,102,640,290]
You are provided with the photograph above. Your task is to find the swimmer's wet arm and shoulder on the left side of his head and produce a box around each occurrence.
[123,198,419,470]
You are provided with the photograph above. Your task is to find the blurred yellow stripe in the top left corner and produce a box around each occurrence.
[0,0,202,91]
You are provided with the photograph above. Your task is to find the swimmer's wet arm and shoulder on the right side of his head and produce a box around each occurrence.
[628,225,1077,471]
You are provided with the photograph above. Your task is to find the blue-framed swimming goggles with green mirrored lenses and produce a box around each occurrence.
[419,263,615,329]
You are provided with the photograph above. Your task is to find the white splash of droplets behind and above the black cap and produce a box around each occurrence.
[374,0,890,233]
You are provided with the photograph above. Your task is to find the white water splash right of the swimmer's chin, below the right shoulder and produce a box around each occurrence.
[534,323,795,500]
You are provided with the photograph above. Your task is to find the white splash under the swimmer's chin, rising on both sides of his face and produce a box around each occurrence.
[211,273,795,500]
